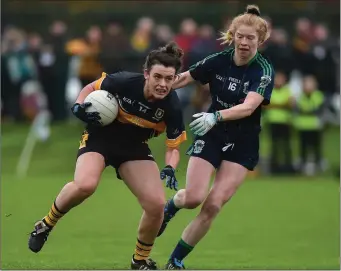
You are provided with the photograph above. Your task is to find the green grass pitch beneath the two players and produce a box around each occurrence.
[1,125,340,270]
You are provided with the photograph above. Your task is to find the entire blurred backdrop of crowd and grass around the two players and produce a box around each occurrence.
[1,0,340,270]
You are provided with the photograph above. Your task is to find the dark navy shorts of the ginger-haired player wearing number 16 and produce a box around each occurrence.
[187,133,259,171]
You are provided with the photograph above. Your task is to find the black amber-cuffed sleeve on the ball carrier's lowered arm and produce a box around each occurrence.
[165,91,187,148]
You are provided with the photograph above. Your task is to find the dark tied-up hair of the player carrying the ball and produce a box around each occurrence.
[143,42,184,73]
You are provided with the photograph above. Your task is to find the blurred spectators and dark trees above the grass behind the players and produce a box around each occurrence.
[1,0,340,178]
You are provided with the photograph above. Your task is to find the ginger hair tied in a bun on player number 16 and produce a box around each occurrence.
[218,5,270,45]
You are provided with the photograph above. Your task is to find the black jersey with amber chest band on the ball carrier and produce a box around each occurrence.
[87,71,186,147]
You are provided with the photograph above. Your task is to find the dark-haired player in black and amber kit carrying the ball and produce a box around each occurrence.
[29,43,186,270]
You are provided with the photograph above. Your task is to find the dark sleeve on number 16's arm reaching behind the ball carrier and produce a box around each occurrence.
[189,53,221,85]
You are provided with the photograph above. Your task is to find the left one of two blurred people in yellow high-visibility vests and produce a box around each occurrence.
[265,71,294,173]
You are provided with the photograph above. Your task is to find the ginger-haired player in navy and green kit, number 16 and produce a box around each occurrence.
[159,5,274,269]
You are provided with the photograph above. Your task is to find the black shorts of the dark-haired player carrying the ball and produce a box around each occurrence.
[77,131,155,179]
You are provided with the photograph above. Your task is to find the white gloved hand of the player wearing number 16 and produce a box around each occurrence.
[189,112,220,136]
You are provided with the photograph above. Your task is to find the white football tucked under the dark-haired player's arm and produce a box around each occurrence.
[84,90,119,126]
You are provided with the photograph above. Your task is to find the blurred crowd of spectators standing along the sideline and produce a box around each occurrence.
[1,17,340,177]
